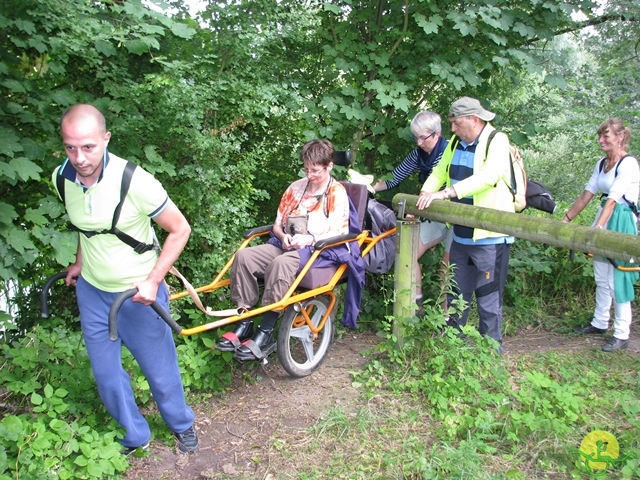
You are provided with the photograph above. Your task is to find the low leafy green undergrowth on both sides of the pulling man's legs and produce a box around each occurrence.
[0,309,234,479]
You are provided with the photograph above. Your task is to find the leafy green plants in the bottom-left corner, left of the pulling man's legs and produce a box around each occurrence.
[0,327,127,479]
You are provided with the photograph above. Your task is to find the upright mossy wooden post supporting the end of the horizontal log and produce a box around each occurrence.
[392,218,420,347]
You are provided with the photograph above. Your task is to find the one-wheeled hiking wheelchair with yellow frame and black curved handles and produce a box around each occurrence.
[41,151,396,378]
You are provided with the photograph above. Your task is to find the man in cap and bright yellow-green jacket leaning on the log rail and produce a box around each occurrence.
[417,97,515,354]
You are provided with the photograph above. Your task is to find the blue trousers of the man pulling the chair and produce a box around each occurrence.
[76,277,194,447]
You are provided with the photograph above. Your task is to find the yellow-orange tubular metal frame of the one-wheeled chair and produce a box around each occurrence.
[169,227,396,337]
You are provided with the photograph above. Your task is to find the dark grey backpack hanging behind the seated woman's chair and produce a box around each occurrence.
[364,198,396,274]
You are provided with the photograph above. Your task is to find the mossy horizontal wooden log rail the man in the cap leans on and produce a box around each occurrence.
[393,193,640,263]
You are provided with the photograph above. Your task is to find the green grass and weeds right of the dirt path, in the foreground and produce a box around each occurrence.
[255,324,640,480]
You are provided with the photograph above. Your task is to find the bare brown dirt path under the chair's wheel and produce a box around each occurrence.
[126,327,640,480]
